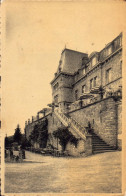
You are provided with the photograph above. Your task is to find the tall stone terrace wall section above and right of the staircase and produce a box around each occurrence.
[69,97,117,147]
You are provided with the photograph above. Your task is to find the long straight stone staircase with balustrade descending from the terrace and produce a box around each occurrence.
[54,108,115,154]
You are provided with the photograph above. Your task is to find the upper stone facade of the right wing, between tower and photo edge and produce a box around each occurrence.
[72,51,122,100]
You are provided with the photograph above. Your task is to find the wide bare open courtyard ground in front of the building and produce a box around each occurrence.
[5,151,121,193]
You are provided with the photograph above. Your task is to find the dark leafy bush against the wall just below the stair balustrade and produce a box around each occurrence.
[53,128,78,150]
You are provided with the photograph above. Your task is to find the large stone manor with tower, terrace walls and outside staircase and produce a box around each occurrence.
[25,33,122,156]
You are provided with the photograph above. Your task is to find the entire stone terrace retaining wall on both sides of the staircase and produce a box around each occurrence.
[26,97,122,152]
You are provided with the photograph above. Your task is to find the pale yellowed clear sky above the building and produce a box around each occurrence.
[2,0,126,135]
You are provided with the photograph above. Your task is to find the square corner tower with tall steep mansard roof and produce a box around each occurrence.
[51,48,88,112]
